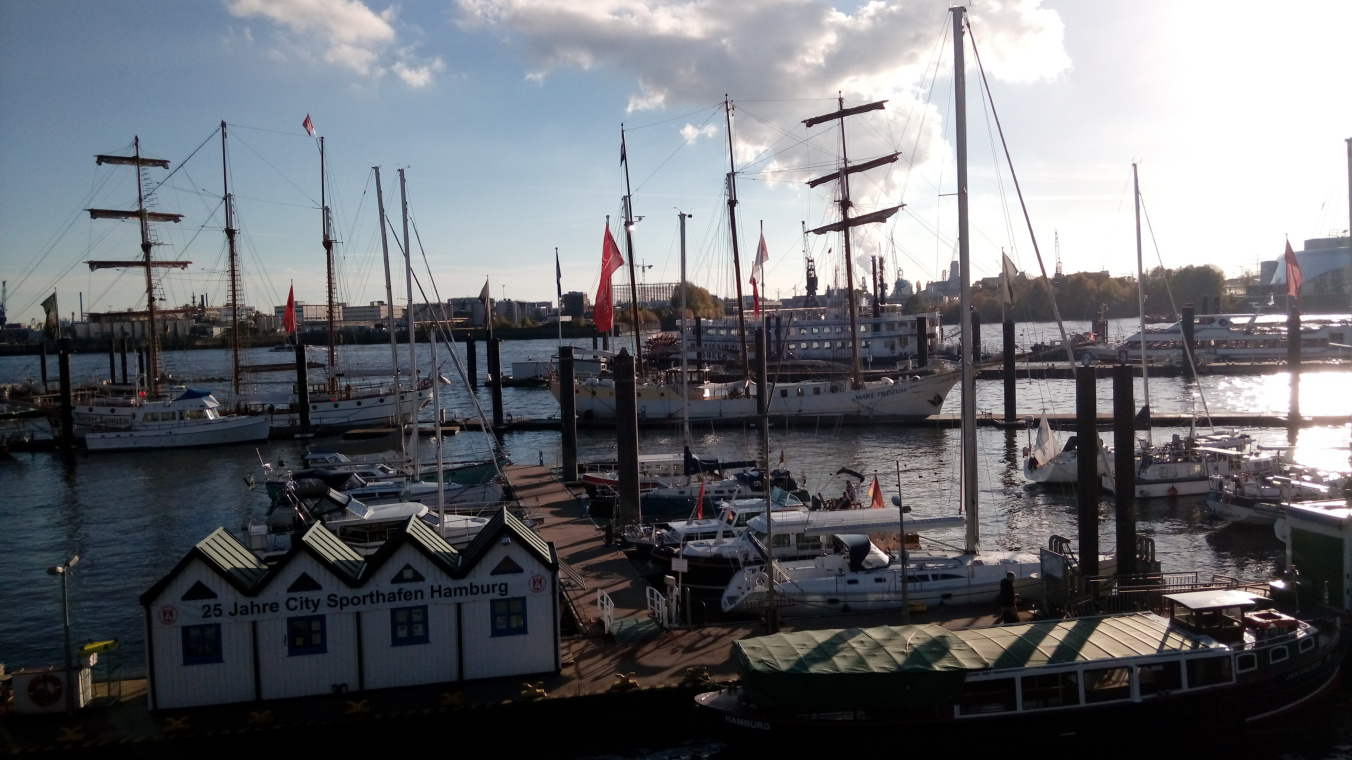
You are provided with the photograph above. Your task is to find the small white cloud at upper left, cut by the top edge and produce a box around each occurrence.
[226,0,445,88]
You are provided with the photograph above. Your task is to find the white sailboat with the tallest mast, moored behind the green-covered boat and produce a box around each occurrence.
[722,74,1041,615]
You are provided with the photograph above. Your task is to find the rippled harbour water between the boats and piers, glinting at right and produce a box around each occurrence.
[0,316,1352,756]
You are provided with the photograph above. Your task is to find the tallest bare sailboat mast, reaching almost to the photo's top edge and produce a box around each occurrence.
[952,5,982,554]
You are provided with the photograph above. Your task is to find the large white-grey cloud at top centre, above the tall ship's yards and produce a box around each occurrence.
[456,0,1069,203]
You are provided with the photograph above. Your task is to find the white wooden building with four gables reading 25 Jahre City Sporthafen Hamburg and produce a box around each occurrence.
[141,510,560,710]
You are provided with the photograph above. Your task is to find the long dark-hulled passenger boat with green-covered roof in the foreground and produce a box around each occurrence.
[695,590,1345,745]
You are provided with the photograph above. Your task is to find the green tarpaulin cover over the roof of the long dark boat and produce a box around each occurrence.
[733,613,1222,713]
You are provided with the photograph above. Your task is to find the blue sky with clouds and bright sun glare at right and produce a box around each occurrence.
[0,0,1352,322]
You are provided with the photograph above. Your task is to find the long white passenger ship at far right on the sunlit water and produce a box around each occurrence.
[1084,314,1352,362]
